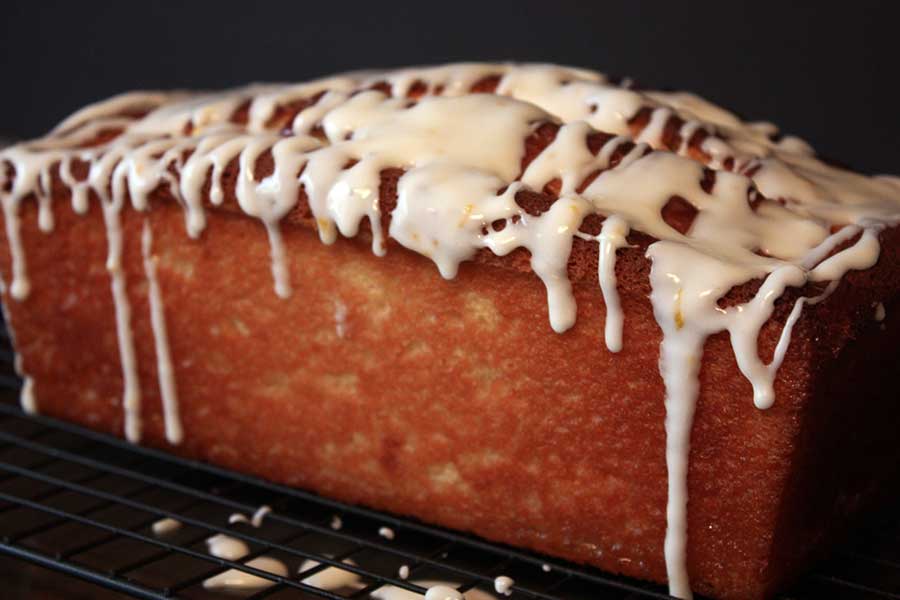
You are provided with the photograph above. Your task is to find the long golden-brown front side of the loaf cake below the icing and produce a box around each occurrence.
[0,195,892,597]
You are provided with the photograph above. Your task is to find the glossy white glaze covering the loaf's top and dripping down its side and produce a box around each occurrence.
[0,64,900,598]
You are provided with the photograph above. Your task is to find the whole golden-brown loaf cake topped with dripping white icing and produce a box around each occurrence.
[0,64,900,598]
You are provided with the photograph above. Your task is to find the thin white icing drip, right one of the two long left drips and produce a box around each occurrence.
[141,221,184,444]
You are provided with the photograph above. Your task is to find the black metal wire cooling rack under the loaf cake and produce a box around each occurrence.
[0,322,900,600]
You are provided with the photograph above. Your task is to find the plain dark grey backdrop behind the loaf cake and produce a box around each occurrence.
[0,0,900,173]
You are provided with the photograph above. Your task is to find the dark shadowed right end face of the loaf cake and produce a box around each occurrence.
[773,228,900,592]
